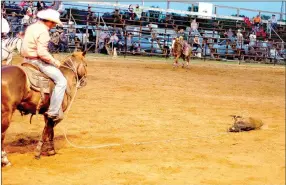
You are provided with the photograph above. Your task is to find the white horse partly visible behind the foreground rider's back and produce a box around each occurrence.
[1,37,23,65]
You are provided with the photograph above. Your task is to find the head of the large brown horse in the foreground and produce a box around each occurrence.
[63,51,87,87]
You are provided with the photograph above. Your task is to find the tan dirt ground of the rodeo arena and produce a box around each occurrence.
[2,56,285,185]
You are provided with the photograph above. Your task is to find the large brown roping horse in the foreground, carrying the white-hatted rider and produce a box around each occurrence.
[1,52,87,166]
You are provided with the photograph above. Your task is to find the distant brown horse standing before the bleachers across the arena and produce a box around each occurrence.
[173,39,192,68]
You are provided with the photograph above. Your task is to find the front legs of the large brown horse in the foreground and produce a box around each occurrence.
[35,117,56,159]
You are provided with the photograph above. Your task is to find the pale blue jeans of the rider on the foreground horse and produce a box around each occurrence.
[25,59,67,116]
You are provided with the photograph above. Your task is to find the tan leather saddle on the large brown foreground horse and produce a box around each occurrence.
[21,63,51,94]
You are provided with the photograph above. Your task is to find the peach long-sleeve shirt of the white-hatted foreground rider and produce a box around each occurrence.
[21,21,56,64]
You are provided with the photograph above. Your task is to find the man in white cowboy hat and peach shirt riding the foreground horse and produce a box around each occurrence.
[22,9,67,121]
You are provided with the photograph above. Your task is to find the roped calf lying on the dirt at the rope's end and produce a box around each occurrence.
[228,115,264,132]
